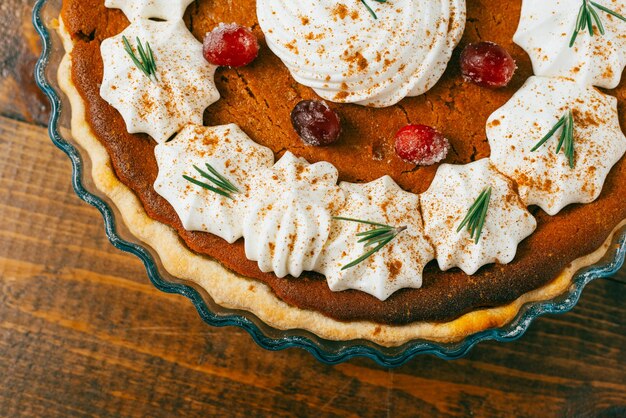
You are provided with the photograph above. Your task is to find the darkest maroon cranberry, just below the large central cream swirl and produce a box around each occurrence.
[291,100,341,146]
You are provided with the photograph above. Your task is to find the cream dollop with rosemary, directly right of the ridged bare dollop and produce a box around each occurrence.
[315,176,434,300]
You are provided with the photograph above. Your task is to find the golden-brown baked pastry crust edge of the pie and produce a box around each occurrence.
[58,18,626,347]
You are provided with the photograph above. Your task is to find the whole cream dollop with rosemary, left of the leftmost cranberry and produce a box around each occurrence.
[100,20,220,143]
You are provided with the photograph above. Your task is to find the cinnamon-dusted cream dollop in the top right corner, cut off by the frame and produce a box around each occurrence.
[513,0,626,89]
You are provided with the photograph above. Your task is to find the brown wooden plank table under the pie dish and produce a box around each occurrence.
[0,0,626,417]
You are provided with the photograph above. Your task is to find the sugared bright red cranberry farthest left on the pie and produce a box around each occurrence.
[202,23,259,67]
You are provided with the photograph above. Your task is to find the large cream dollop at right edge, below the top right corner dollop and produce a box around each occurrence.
[487,77,626,215]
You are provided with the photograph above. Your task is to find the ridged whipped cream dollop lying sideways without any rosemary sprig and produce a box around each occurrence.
[242,152,344,277]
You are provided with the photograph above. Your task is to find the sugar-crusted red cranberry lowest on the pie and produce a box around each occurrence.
[396,125,450,165]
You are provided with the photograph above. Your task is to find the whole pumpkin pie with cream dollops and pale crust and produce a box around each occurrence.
[54,0,626,346]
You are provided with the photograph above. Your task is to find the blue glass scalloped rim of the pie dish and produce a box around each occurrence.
[33,0,626,367]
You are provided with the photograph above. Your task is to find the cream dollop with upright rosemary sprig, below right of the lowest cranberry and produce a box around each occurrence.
[421,159,537,275]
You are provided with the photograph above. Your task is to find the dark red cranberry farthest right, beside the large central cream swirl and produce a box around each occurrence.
[461,42,517,89]
